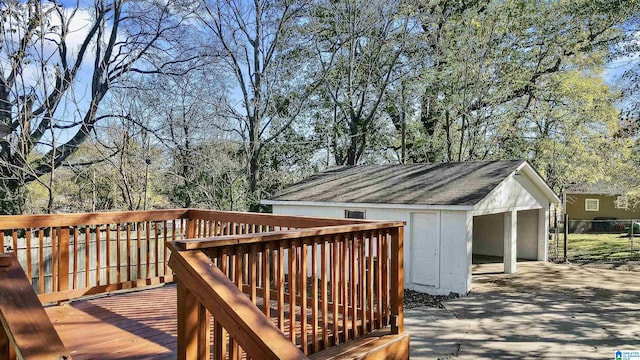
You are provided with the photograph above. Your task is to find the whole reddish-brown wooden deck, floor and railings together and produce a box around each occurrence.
[0,209,408,360]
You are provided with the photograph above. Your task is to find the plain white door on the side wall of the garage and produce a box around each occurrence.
[411,212,440,287]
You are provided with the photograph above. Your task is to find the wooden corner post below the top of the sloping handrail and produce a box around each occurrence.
[177,279,211,360]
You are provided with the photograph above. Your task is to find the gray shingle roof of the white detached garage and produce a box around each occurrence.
[271,160,524,205]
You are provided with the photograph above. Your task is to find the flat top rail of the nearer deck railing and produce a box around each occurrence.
[173,221,405,250]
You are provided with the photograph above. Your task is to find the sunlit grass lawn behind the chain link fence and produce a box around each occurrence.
[549,233,640,262]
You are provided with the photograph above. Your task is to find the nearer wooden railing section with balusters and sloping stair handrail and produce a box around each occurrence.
[169,214,404,359]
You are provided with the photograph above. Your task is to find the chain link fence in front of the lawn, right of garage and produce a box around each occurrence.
[549,216,640,263]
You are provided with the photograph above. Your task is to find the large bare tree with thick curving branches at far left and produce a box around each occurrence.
[0,0,200,213]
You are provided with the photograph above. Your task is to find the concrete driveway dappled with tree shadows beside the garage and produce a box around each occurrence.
[405,262,640,359]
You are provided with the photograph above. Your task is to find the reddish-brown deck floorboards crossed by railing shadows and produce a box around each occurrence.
[46,285,177,360]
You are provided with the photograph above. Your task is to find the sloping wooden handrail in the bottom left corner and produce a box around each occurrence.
[0,254,71,359]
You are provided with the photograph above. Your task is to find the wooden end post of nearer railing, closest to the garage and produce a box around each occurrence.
[391,226,404,334]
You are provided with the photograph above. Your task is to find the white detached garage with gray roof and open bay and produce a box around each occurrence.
[262,160,560,295]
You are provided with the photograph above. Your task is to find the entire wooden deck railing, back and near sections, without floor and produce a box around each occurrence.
[0,209,408,359]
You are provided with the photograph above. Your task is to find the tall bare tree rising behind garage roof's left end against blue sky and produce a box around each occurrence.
[201,0,315,208]
